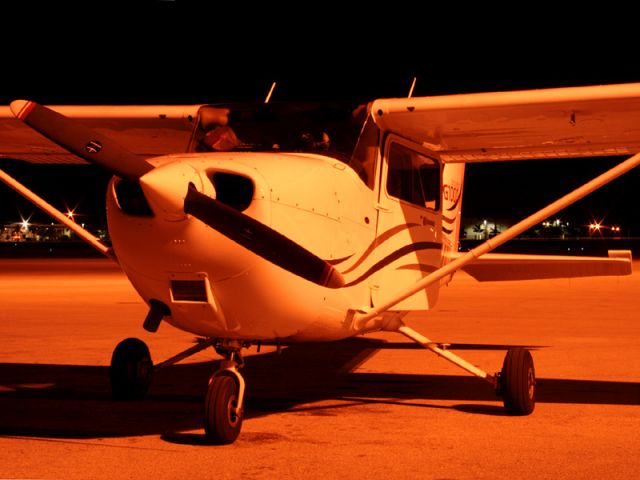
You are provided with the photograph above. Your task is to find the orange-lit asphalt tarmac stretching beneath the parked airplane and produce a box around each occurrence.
[0,260,640,479]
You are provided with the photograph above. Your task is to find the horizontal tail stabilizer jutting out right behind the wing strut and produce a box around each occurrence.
[461,250,631,282]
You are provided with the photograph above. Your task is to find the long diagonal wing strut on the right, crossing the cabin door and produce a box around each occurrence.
[354,153,640,324]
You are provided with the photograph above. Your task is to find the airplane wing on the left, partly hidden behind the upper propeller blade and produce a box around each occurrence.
[0,105,201,163]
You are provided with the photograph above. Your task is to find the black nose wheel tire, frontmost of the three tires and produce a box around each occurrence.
[204,372,243,445]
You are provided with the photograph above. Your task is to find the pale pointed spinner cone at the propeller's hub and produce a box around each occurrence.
[140,161,208,222]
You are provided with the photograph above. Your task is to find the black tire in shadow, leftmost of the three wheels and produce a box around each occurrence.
[109,338,153,400]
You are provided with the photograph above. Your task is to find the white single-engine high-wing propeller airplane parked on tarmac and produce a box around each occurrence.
[0,84,640,444]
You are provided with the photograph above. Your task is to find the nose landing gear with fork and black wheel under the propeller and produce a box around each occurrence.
[204,342,245,445]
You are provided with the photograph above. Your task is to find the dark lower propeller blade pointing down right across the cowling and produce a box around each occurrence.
[184,185,344,288]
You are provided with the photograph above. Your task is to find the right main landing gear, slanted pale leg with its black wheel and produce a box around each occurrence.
[397,325,536,415]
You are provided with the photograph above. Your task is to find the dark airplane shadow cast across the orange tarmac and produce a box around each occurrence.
[0,339,640,443]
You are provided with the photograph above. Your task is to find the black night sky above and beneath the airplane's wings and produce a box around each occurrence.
[0,5,640,235]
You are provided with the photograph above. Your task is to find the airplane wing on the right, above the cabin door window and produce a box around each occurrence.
[371,83,640,163]
